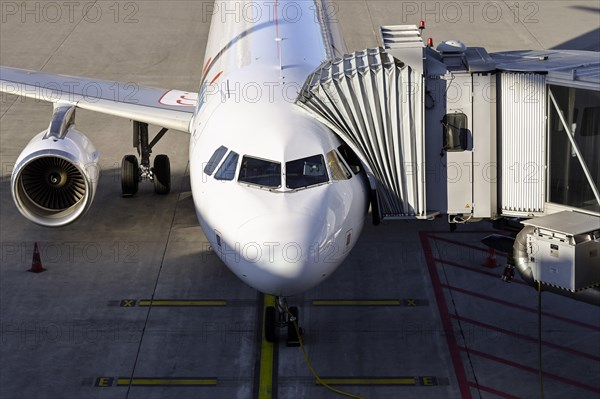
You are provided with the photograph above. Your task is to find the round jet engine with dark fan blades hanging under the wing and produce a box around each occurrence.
[11,125,100,227]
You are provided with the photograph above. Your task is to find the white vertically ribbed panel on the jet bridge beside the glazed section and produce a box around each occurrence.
[500,72,546,215]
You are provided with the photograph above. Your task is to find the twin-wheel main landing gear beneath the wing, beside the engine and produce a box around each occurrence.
[121,121,171,197]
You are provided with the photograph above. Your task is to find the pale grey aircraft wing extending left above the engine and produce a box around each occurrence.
[0,66,198,132]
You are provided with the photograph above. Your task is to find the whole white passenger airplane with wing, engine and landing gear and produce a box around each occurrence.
[0,0,370,344]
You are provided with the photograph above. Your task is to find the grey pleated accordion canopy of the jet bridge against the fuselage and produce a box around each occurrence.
[296,44,435,221]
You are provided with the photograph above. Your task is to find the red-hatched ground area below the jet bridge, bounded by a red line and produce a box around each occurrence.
[420,231,600,399]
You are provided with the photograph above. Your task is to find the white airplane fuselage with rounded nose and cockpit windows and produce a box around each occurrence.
[189,1,368,296]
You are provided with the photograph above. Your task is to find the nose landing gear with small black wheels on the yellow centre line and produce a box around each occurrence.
[265,297,302,346]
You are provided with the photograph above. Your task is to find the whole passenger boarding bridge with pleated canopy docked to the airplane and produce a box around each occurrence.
[296,25,600,304]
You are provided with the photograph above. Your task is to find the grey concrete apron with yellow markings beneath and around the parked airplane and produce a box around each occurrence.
[0,1,600,399]
